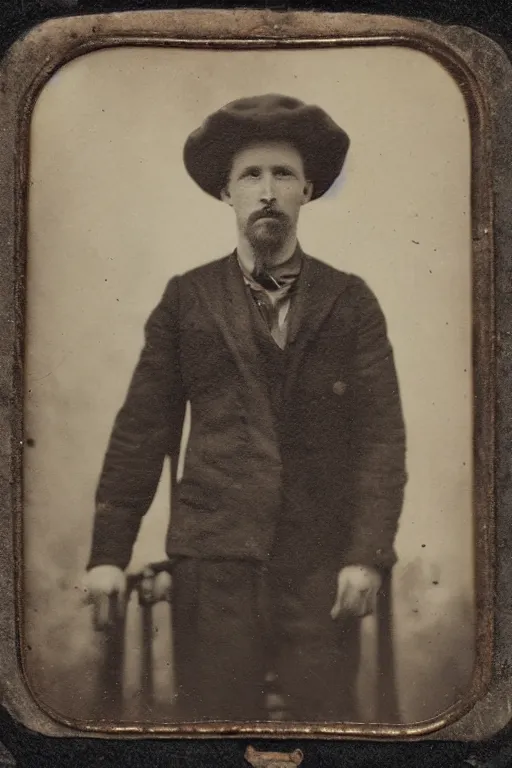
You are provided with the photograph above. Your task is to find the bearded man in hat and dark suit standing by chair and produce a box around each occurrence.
[87,95,405,722]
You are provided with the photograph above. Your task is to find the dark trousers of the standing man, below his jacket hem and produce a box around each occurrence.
[173,556,360,722]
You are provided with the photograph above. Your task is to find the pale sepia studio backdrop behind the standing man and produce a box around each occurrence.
[24,47,474,722]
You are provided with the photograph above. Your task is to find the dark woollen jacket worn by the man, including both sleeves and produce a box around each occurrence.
[89,255,405,567]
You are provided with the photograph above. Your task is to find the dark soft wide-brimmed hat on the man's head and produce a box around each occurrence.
[183,94,349,200]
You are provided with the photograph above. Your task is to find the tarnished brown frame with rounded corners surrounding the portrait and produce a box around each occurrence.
[0,11,504,739]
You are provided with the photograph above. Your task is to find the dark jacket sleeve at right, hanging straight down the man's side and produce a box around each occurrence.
[344,278,406,568]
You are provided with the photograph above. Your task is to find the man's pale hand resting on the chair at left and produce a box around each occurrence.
[82,565,126,630]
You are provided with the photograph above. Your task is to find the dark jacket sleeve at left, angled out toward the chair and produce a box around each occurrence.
[87,278,186,569]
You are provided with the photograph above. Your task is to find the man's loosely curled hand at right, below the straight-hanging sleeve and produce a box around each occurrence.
[331,565,382,619]
